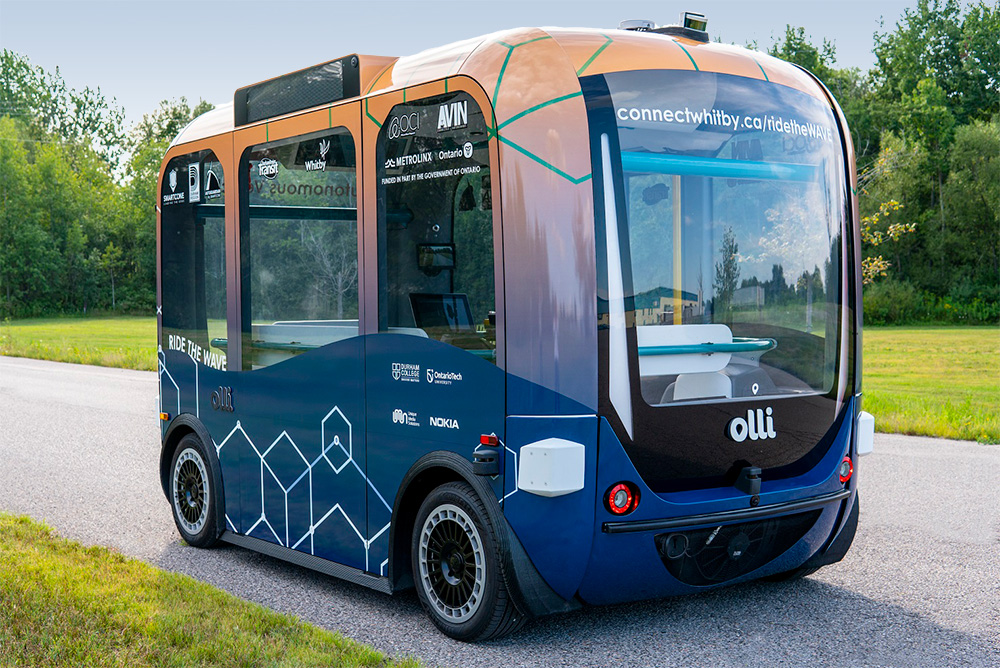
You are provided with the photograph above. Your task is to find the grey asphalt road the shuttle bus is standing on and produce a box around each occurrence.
[0,357,1000,668]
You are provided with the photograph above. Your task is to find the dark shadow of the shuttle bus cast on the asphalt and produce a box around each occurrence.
[157,541,1000,668]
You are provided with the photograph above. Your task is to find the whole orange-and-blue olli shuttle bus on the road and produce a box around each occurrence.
[157,15,874,640]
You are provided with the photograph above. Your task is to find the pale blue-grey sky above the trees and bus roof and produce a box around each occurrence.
[0,0,948,129]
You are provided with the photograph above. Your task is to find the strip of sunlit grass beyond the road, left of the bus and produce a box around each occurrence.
[0,316,156,371]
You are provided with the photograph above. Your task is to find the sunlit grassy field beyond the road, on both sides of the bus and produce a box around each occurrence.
[0,317,1000,443]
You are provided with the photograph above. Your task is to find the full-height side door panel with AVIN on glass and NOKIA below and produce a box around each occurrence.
[364,81,505,574]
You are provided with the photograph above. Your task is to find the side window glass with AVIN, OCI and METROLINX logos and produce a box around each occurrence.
[377,92,496,360]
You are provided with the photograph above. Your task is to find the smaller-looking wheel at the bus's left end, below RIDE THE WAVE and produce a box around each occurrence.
[169,434,222,547]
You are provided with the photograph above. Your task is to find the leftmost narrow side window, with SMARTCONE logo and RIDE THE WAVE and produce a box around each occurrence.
[160,151,227,370]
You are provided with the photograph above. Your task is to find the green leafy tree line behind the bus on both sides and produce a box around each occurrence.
[0,0,1000,322]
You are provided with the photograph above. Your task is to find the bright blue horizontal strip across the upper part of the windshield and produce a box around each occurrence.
[622,151,818,182]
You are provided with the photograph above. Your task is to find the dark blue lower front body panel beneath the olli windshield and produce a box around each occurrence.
[505,404,856,604]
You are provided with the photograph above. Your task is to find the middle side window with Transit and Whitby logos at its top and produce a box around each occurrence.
[240,129,358,370]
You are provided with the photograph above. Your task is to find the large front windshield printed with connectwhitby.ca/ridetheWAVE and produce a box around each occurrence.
[605,71,846,406]
